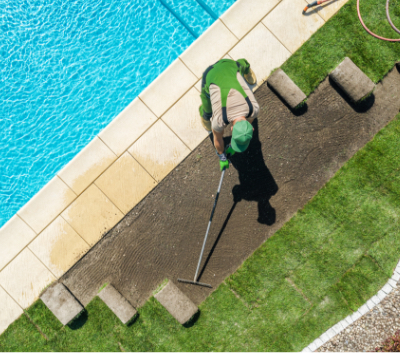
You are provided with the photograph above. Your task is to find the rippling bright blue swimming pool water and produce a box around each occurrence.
[0,0,235,226]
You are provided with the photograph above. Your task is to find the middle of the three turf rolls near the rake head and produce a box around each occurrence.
[98,284,137,324]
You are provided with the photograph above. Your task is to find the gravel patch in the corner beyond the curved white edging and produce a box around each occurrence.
[317,282,400,352]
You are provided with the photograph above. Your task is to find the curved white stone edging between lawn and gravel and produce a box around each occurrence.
[302,261,400,352]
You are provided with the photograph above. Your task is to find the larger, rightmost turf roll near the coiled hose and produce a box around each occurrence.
[329,57,375,102]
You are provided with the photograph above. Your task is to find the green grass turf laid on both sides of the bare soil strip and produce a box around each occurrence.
[0,0,400,351]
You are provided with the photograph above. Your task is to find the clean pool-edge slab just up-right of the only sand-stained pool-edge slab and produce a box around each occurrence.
[99,98,157,156]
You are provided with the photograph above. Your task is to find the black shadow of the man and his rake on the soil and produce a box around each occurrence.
[198,119,278,280]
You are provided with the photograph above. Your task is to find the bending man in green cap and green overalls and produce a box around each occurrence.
[200,59,259,171]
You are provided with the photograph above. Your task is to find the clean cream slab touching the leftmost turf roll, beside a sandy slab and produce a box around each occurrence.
[0,248,56,309]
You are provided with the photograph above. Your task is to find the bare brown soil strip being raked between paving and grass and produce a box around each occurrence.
[61,69,400,306]
